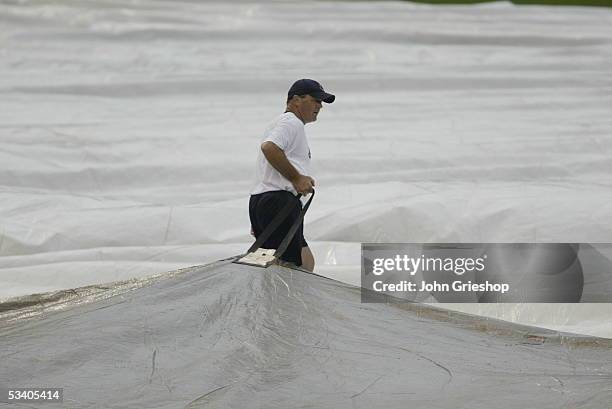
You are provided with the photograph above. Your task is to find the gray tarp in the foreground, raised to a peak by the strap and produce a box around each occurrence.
[0,261,612,409]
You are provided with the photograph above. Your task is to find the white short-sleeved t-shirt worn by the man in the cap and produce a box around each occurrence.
[251,112,311,195]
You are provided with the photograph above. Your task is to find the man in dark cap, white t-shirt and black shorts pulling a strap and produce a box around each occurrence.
[249,79,336,271]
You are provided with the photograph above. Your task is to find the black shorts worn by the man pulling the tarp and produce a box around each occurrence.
[249,190,308,266]
